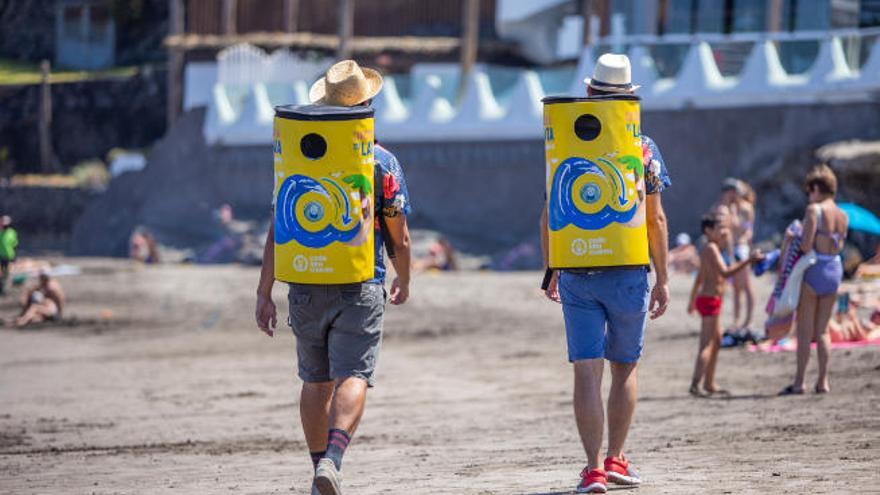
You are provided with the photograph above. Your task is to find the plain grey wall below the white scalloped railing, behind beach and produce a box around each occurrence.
[73,101,880,264]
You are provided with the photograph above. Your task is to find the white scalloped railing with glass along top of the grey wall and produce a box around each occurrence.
[198,30,880,145]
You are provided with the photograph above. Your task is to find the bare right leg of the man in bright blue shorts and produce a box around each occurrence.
[608,362,638,457]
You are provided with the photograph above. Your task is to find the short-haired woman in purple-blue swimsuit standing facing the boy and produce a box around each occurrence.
[780,165,849,395]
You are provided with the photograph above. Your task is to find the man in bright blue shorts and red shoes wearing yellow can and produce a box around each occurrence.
[541,53,671,493]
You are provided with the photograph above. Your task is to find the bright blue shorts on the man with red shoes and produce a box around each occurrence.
[559,268,648,363]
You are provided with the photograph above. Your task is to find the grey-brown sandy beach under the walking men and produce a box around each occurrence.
[0,259,880,495]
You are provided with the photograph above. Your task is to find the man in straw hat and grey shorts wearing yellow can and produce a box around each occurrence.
[256,60,410,495]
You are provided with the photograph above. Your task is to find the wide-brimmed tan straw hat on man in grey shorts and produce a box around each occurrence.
[309,60,382,107]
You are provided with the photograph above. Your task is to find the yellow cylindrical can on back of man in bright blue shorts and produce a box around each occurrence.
[543,95,650,269]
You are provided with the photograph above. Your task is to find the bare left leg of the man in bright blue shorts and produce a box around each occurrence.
[574,358,605,469]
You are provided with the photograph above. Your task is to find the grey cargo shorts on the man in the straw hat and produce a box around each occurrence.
[287,283,386,387]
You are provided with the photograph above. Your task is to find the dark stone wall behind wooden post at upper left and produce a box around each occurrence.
[0,68,166,173]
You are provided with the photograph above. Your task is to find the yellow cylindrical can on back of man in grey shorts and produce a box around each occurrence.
[273,105,375,285]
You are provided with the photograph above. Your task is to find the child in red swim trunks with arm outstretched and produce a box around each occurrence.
[688,216,763,396]
